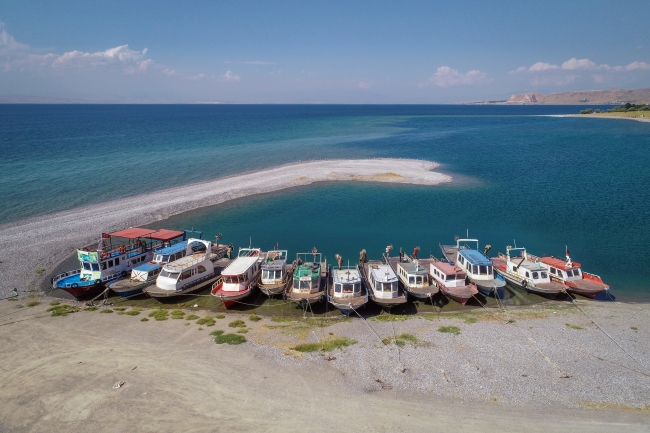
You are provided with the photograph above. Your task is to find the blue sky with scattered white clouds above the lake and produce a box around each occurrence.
[0,0,650,104]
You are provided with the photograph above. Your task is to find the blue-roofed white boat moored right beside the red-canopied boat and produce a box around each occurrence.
[107,231,232,297]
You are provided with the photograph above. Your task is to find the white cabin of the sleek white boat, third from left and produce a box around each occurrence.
[156,239,214,291]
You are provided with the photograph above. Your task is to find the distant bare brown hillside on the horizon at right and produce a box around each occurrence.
[506,88,650,105]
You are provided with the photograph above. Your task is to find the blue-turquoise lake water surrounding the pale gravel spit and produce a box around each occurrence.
[0,106,650,300]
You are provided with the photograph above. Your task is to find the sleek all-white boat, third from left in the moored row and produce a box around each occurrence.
[142,238,219,298]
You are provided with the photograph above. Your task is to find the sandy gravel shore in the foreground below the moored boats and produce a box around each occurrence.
[0,295,650,433]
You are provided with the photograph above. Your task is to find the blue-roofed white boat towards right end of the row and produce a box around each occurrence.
[440,238,506,299]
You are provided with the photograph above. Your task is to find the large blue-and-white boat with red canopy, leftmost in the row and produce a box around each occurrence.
[52,227,185,298]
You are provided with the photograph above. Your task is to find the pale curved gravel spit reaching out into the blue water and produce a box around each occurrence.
[0,159,451,297]
